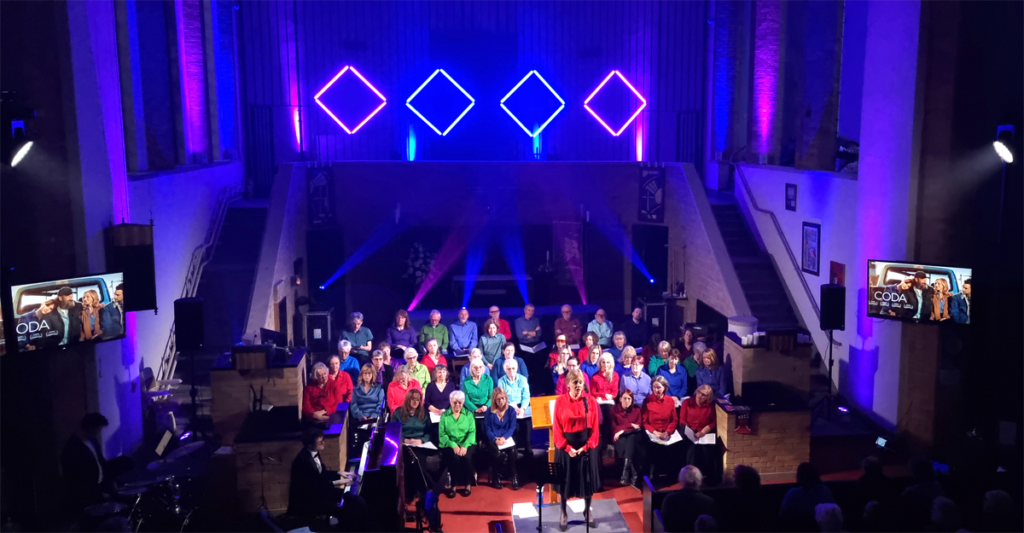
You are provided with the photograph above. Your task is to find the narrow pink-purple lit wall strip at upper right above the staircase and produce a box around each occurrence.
[752,0,782,154]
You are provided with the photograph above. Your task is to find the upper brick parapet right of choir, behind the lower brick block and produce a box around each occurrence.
[725,336,816,396]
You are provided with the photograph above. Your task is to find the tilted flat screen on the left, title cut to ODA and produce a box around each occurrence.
[10,273,125,352]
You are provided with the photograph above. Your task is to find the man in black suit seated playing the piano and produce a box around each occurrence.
[288,428,370,531]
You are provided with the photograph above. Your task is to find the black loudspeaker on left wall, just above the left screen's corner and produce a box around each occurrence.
[105,220,157,311]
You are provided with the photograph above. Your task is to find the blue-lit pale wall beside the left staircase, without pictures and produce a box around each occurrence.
[128,162,244,371]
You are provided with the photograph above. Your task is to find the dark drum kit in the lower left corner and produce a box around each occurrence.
[85,442,206,533]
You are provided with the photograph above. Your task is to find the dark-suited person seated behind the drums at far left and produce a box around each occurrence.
[60,412,131,514]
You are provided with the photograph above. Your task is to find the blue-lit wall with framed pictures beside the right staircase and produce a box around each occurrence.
[735,165,866,392]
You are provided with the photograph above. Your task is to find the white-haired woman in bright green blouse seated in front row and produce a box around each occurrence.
[438,391,476,498]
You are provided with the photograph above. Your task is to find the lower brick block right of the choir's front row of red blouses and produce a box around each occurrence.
[716,406,811,481]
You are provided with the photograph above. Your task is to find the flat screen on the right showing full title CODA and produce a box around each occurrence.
[867,260,971,324]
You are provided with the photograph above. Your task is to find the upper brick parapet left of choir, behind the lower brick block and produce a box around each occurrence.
[210,357,306,444]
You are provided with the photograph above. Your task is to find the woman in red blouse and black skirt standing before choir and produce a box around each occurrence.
[552,370,601,531]
